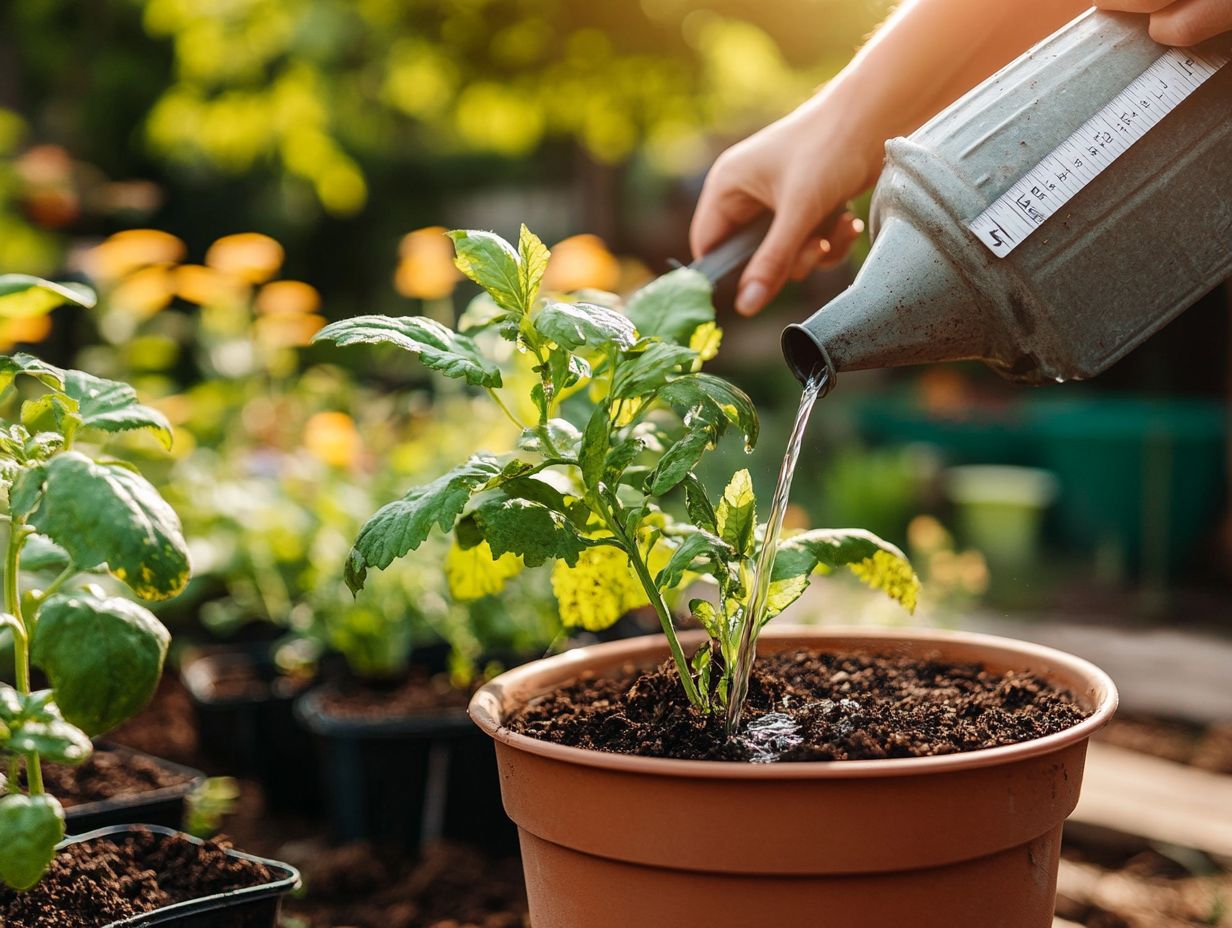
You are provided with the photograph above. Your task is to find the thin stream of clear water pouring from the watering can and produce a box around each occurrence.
[727,367,830,738]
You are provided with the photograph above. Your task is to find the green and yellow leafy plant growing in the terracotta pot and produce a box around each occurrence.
[317,227,918,712]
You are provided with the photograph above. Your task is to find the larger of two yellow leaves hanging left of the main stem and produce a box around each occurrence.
[552,545,650,631]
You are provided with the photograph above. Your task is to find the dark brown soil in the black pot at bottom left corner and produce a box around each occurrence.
[0,832,274,928]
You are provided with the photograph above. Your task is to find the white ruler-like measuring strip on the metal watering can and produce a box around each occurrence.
[967,48,1232,258]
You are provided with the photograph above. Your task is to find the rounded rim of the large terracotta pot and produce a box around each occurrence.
[467,625,1119,781]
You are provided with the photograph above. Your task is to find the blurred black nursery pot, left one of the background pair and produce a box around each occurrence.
[180,645,322,813]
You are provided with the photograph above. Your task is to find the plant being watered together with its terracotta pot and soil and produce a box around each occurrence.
[319,229,1115,928]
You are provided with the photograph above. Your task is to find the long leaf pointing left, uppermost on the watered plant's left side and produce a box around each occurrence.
[313,315,500,387]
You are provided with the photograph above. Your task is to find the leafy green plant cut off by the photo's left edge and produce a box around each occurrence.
[0,277,188,890]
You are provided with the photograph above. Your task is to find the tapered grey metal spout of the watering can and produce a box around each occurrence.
[782,217,986,382]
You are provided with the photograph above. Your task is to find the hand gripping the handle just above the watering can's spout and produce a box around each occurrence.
[690,108,880,315]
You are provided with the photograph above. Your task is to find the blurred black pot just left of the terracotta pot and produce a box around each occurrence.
[296,688,517,853]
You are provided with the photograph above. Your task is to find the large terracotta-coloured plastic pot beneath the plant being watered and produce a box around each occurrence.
[471,627,1116,928]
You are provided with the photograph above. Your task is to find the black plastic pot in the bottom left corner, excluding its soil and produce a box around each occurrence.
[60,824,301,928]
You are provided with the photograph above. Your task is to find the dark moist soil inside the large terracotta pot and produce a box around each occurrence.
[509,649,1085,762]
